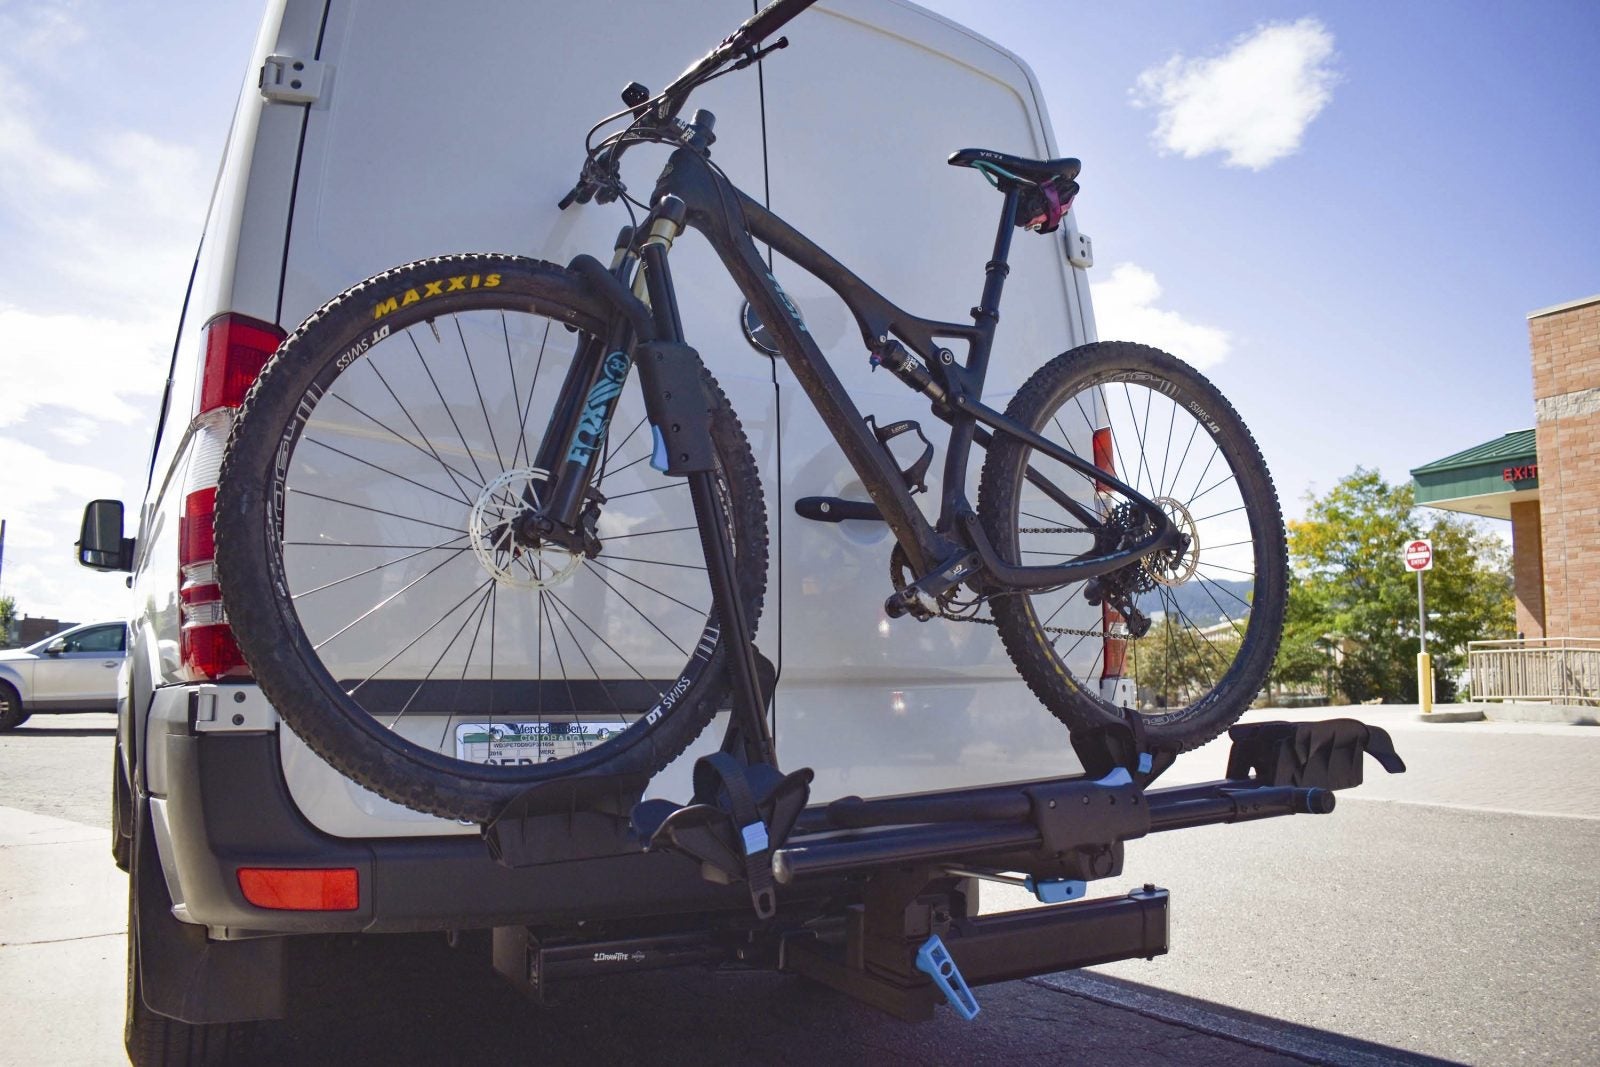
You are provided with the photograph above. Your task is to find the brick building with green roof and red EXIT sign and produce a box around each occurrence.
[1411,296,1600,637]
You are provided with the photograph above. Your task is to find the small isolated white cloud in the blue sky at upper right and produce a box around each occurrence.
[1131,18,1338,171]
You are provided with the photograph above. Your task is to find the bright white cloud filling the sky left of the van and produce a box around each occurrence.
[0,2,211,621]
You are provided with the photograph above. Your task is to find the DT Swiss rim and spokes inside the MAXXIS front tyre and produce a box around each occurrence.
[256,300,733,777]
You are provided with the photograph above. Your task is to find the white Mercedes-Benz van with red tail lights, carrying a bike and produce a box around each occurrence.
[85,0,1098,1062]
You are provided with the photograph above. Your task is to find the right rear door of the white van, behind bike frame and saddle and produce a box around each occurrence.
[766,0,1099,800]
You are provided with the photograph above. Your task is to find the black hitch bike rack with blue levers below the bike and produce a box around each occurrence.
[485,710,1405,1021]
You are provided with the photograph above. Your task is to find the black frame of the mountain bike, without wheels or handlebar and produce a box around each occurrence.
[546,147,1176,601]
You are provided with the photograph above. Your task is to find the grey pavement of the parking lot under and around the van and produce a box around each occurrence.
[0,707,1600,1067]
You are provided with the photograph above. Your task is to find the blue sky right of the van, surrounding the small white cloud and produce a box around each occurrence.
[931,0,1600,514]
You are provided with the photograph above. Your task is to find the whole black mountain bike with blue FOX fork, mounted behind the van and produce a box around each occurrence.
[214,0,1286,822]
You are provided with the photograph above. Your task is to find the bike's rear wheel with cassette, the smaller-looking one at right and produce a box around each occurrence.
[978,342,1288,750]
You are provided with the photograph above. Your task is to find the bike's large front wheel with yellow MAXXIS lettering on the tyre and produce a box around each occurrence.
[214,256,766,822]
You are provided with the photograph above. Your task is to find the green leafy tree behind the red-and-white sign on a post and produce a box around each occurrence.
[1290,467,1515,701]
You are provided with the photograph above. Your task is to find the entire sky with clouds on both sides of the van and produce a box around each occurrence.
[0,0,1600,619]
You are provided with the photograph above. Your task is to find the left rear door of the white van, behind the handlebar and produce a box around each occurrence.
[282,0,779,837]
